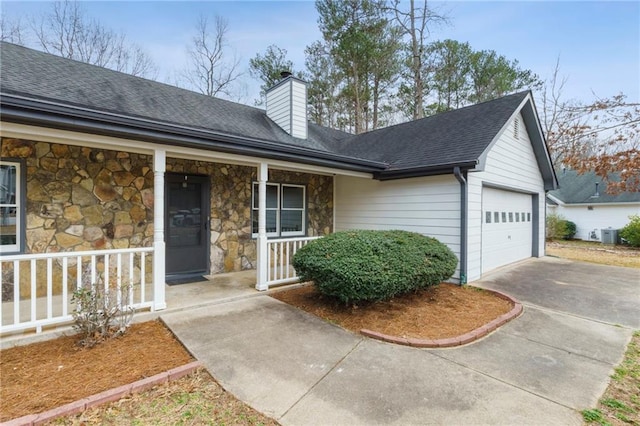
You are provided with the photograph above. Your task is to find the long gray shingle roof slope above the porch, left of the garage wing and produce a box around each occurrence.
[0,43,347,151]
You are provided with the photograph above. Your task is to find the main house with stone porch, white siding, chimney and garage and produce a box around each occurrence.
[0,43,557,332]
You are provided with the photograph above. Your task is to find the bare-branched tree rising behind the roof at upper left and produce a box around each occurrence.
[32,0,157,78]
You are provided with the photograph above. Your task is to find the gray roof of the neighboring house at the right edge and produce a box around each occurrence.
[549,169,640,204]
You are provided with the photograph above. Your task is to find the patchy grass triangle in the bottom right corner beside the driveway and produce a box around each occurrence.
[582,331,640,426]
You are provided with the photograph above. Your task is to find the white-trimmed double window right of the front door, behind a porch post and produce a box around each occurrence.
[251,182,307,238]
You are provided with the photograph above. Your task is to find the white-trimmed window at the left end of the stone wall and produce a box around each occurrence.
[0,160,23,253]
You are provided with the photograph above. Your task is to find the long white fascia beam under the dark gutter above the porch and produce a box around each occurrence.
[0,121,373,179]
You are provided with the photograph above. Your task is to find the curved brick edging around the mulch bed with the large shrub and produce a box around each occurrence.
[360,289,523,348]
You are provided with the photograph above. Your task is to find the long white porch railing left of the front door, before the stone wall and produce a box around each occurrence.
[0,247,153,335]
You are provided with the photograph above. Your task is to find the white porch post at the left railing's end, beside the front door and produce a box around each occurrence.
[153,149,167,311]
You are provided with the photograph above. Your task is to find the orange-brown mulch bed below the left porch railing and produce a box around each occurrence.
[0,321,194,421]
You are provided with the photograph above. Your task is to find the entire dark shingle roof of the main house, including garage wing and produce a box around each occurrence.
[0,42,555,186]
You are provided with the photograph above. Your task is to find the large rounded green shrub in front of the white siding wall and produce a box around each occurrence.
[293,230,458,304]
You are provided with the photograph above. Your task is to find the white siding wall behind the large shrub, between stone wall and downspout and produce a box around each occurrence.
[334,175,460,281]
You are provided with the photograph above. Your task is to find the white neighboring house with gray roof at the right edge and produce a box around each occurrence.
[547,169,640,241]
